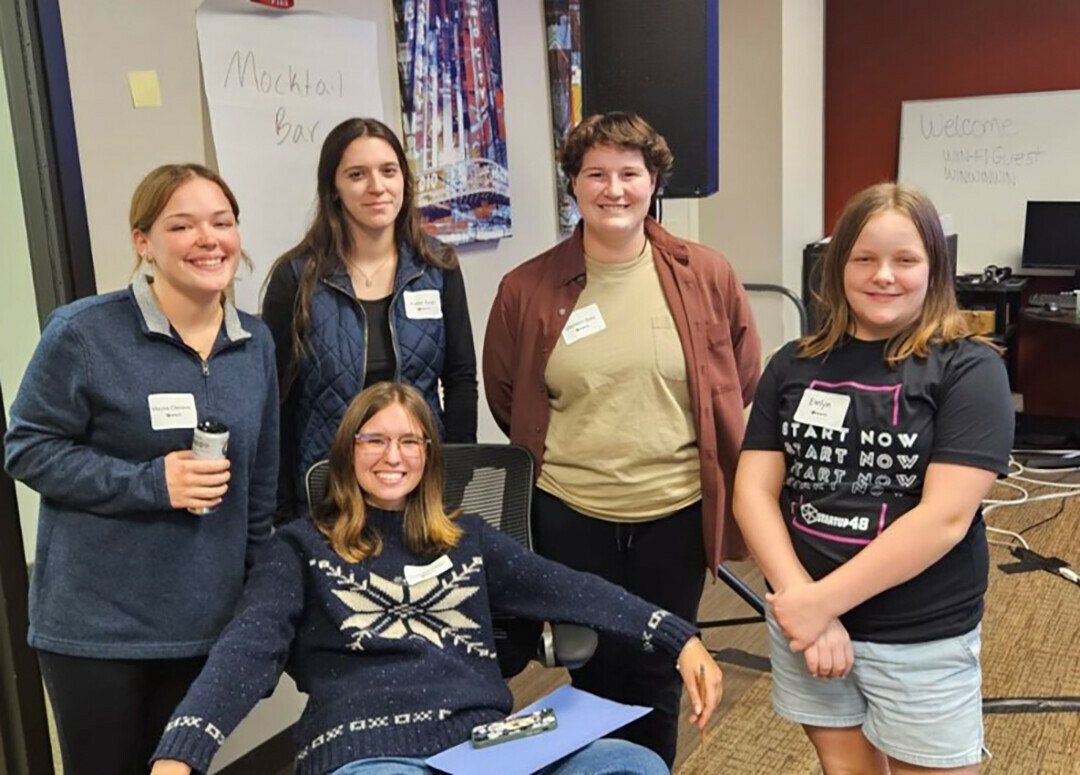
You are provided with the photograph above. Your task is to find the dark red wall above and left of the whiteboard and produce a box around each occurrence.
[825,0,1080,228]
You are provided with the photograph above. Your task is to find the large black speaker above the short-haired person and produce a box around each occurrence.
[581,0,720,199]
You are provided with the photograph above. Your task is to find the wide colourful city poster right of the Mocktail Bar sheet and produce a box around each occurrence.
[393,0,512,245]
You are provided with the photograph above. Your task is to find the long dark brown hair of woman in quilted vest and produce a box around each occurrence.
[267,119,458,386]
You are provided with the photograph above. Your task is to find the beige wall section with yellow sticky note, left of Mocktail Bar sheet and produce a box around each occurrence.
[59,0,211,293]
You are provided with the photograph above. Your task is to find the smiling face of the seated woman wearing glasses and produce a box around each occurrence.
[353,404,427,511]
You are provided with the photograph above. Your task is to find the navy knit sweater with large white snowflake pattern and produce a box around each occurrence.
[152,508,697,775]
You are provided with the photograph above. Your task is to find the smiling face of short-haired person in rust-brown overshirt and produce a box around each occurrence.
[573,145,657,243]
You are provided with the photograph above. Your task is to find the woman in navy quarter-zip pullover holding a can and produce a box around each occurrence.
[4,164,278,775]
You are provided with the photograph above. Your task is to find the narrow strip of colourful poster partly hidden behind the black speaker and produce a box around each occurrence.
[544,0,583,234]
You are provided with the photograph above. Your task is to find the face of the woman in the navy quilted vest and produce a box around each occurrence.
[334,137,405,236]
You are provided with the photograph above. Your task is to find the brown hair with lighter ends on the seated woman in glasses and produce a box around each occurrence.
[311,382,461,562]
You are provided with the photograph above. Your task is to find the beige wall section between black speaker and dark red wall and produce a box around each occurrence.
[699,0,823,352]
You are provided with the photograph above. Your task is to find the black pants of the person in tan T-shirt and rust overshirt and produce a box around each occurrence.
[532,490,705,767]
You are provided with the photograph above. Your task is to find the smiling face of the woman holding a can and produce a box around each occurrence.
[132,177,240,300]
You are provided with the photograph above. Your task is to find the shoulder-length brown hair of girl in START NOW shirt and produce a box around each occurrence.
[799,182,994,367]
